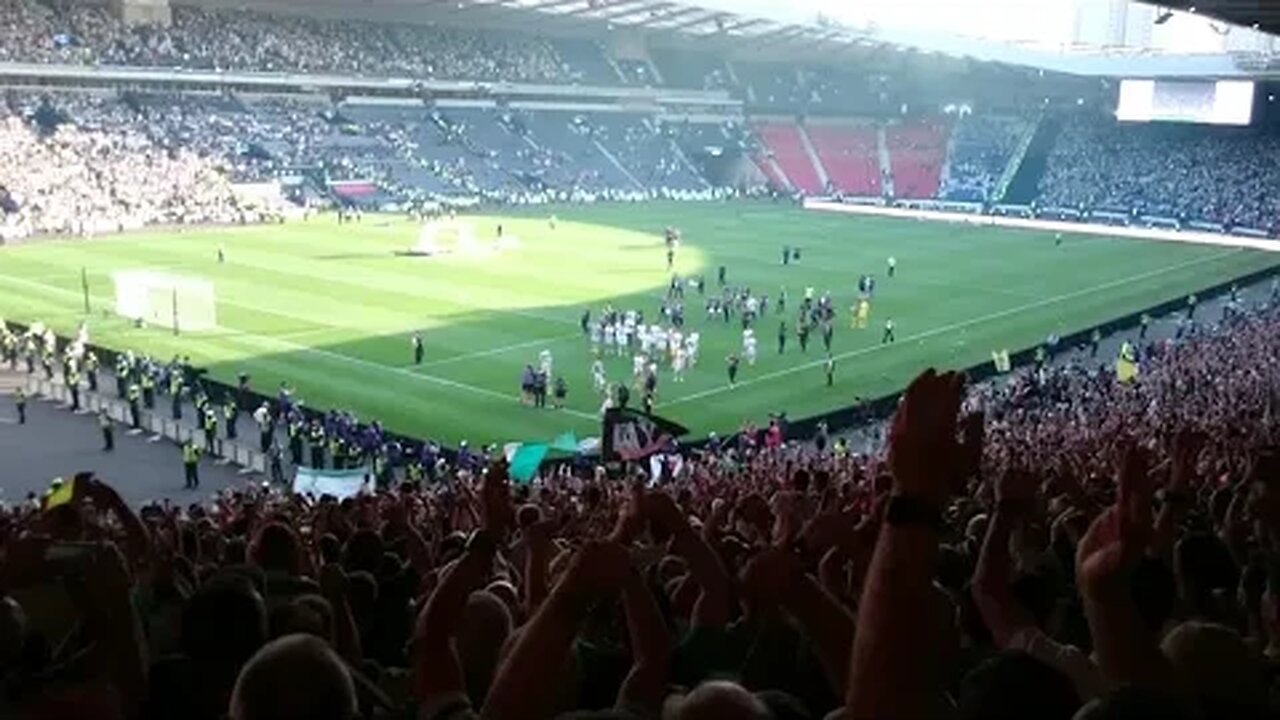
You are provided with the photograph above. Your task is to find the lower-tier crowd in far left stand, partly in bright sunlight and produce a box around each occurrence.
[0,83,742,237]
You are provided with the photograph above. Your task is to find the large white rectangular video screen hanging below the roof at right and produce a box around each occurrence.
[1116,79,1253,126]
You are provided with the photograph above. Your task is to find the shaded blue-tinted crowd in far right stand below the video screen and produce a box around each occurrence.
[1039,114,1280,231]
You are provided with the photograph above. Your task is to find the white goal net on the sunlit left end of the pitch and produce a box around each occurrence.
[111,270,218,331]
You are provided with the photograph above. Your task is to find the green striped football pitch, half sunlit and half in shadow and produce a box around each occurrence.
[0,202,1280,443]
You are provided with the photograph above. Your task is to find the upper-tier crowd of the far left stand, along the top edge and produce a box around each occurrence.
[0,0,579,83]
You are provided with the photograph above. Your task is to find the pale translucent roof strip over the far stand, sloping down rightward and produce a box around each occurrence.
[422,0,1280,77]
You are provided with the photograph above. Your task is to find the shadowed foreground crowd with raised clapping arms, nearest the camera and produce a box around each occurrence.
[0,251,1280,720]
